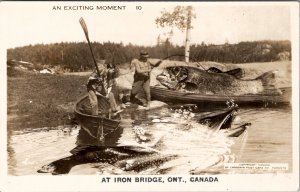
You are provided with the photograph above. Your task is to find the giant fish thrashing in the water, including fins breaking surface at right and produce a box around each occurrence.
[37,103,250,175]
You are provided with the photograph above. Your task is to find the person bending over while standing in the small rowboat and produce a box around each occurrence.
[87,60,119,115]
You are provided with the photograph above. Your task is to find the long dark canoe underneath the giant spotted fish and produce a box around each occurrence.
[151,86,291,104]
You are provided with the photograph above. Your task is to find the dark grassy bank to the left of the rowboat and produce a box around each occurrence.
[8,70,86,130]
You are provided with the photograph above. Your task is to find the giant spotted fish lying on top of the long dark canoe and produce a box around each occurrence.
[156,66,282,95]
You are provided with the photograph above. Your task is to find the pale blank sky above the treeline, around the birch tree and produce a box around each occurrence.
[0,2,291,48]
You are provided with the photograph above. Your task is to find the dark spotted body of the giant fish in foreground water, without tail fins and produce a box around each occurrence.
[37,146,177,175]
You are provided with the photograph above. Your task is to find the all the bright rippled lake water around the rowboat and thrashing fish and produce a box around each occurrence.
[8,106,293,175]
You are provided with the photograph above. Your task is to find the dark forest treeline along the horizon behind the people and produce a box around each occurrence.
[7,41,291,71]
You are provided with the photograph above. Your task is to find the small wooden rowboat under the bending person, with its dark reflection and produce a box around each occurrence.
[74,95,121,146]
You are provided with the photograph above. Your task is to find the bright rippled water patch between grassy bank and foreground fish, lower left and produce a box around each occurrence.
[8,127,79,175]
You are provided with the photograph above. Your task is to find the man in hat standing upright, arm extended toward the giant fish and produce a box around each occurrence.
[130,51,162,108]
